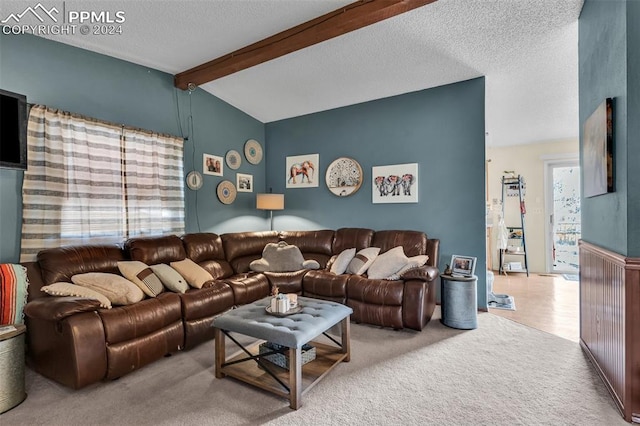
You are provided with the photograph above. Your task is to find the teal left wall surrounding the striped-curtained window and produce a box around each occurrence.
[0,35,268,262]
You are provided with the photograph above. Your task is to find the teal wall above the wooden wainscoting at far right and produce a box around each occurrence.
[578,0,640,257]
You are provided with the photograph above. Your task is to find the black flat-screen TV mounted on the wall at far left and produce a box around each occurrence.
[0,89,27,170]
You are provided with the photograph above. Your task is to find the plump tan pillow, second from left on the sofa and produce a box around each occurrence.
[71,272,144,305]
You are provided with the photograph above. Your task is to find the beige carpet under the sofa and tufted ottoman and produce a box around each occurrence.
[0,311,626,426]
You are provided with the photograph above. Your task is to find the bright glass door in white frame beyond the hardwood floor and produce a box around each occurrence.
[545,159,581,274]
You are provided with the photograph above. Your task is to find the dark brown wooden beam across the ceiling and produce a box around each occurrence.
[174,0,436,90]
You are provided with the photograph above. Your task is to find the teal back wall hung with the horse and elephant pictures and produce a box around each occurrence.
[266,78,487,308]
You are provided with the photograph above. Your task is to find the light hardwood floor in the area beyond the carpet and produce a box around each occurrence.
[489,271,580,342]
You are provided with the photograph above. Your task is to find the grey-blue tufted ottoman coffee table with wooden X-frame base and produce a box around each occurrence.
[213,297,353,409]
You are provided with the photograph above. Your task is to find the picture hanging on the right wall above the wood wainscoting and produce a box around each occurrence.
[582,98,614,197]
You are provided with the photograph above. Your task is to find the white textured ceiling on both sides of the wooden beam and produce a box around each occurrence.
[0,0,583,147]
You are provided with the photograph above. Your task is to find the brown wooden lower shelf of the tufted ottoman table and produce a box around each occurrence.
[222,341,349,398]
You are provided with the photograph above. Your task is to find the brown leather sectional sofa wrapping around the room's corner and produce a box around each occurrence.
[25,228,439,388]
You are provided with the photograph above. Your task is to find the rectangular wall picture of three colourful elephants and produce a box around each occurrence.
[371,163,418,204]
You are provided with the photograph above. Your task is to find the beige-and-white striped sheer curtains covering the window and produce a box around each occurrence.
[20,105,184,262]
